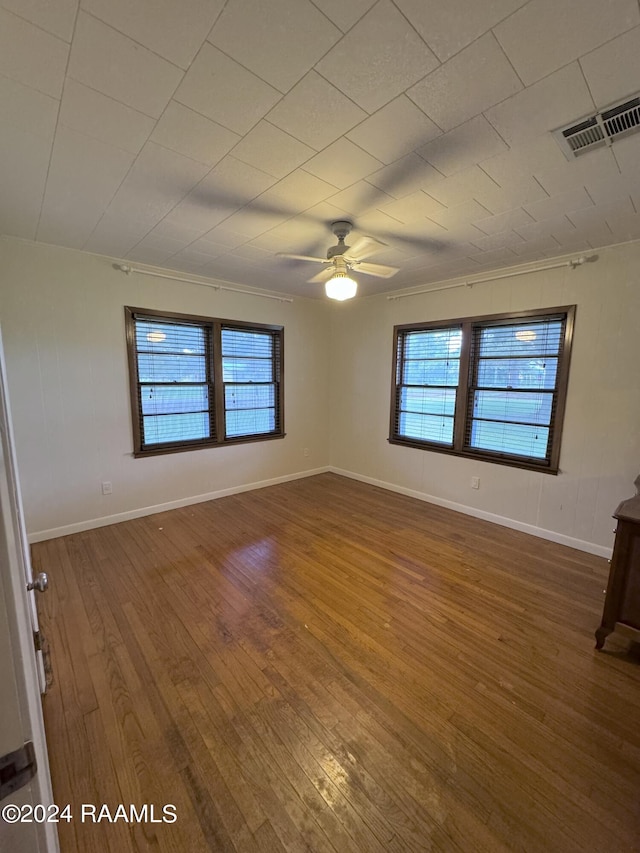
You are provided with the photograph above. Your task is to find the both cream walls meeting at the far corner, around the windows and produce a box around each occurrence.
[0,238,640,554]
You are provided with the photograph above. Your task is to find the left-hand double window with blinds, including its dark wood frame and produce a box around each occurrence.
[125,308,284,456]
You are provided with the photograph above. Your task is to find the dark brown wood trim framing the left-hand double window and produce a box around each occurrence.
[124,306,285,457]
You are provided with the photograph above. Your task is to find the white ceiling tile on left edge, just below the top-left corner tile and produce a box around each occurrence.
[0,8,69,98]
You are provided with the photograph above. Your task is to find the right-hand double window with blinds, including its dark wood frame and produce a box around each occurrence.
[389,306,575,473]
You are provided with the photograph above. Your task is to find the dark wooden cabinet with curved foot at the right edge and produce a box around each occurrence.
[596,475,640,649]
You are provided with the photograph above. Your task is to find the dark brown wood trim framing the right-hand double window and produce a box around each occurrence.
[389,305,576,474]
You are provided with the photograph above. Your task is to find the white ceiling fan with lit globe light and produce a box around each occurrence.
[277,219,398,301]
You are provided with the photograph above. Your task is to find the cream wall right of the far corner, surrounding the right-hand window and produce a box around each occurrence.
[330,243,640,554]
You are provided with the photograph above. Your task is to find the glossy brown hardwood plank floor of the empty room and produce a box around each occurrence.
[33,474,640,853]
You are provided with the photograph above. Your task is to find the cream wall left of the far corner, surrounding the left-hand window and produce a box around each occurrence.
[0,238,329,539]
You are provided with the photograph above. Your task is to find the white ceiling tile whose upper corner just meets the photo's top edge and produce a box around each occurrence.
[316,0,438,113]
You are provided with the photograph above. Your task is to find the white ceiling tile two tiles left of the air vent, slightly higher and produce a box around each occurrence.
[407,33,522,130]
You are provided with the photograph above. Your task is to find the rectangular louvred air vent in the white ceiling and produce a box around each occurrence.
[553,97,640,160]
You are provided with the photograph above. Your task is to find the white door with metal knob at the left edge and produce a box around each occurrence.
[0,324,59,853]
